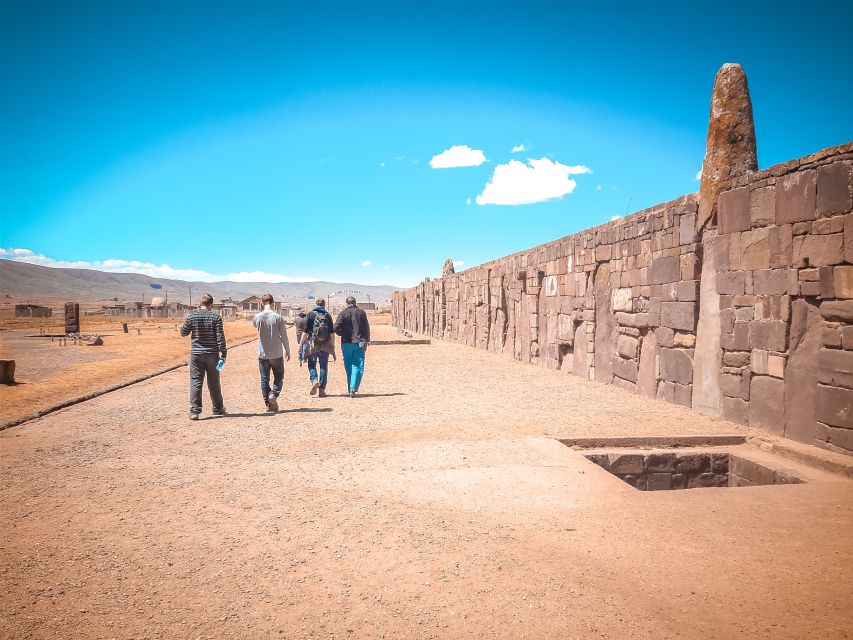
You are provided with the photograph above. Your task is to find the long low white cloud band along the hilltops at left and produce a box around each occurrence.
[0,248,316,282]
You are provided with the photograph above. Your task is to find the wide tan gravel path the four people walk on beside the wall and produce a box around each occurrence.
[0,327,853,640]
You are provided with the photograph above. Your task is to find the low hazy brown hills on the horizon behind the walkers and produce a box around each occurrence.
[0,260,398,303]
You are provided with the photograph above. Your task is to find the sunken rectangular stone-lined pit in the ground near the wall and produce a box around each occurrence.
[585,450,805,491]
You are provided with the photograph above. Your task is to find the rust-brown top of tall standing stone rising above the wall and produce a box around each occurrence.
[697,63,758,230]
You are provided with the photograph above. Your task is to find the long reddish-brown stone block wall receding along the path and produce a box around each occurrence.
[393,144,853,453]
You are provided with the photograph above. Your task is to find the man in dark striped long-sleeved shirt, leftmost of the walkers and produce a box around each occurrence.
[181,293,228,420]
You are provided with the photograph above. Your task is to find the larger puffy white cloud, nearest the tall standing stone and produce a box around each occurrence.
[477,158,592,205]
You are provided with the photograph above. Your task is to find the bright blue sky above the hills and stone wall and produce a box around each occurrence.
[0,0,853,286]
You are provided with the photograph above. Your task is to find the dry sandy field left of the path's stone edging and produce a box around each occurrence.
[0,318,255,424]
